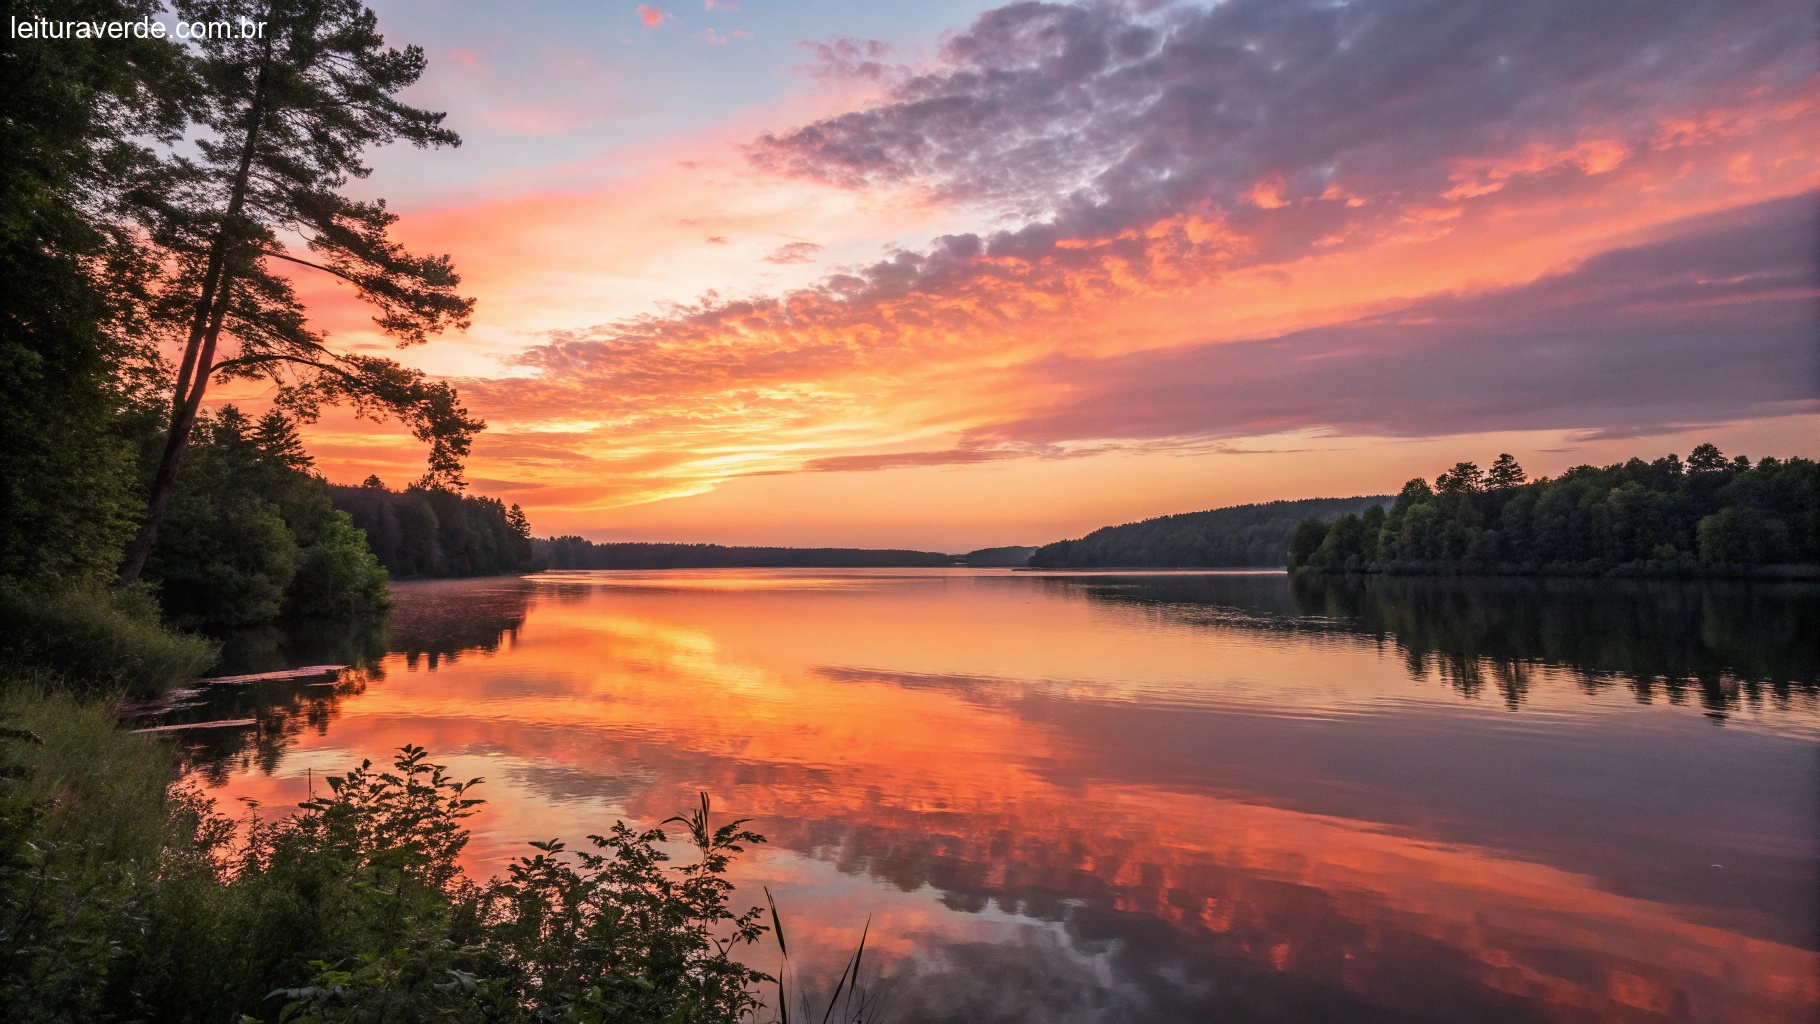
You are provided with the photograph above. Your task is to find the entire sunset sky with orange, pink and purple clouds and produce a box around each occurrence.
[231,0,1820,551]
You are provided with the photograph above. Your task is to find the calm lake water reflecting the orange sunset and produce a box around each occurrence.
[163,569,1820,1024]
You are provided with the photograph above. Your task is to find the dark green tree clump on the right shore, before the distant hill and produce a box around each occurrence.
[1287,444,1820,577]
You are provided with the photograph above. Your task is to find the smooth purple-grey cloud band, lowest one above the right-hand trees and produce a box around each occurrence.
[970,195,1820,444]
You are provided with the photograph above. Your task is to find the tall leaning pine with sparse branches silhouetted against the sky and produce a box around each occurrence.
[120,0,484,580]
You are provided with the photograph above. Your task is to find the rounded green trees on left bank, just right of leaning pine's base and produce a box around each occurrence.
[147,406,388,627]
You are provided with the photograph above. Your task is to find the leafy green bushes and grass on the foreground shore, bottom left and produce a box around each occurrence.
[0,720,768,1024]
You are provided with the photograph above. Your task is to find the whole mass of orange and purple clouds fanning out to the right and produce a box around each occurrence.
[440,0,1820,512]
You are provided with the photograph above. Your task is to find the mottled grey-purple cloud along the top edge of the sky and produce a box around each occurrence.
[750,0,1820,235]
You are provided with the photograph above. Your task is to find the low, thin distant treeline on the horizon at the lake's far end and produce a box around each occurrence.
[531,537,956,569]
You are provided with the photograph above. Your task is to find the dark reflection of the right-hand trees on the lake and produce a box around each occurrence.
[1054,575,1820,718]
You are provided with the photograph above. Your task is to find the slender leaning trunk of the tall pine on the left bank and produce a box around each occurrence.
[120,38,271,584]
